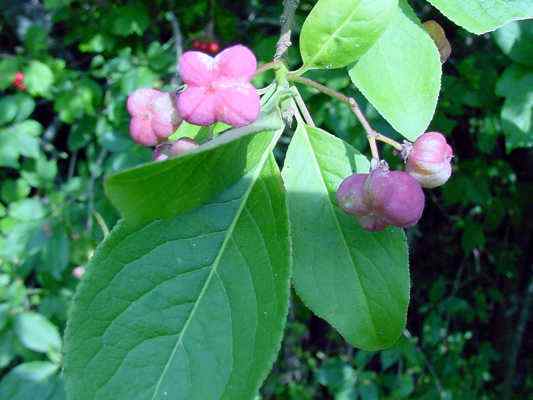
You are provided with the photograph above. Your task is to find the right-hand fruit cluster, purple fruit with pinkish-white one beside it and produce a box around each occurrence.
[337,132,453,231]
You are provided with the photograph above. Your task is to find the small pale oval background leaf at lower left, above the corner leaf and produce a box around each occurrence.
[15,312,61,353]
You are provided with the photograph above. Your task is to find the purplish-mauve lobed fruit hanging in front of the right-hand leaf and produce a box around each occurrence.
[337,166,425,231]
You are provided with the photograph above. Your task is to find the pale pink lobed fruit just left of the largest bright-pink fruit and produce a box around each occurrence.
[127,88,181,146]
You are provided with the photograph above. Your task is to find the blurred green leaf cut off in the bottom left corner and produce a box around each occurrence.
[0,361,65,400]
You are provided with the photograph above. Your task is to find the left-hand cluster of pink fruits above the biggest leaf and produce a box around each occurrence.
[127,45,260,160]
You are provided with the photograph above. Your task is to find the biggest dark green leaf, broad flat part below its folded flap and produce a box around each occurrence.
[65,143,289,400]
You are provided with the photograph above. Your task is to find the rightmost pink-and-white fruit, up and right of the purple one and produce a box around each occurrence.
[406,132,453,189]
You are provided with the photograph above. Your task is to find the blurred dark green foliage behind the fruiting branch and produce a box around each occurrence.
[0,0,533,400]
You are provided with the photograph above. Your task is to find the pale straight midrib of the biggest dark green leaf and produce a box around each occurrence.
[151,130,282,400]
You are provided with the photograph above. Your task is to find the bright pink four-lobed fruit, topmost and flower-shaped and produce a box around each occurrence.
[178,45,261,127]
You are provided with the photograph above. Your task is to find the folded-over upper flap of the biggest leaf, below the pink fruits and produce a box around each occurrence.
[105,116,281,227]
